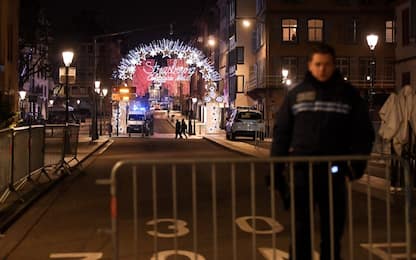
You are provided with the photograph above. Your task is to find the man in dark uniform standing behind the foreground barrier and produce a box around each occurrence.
[271,43,374,260]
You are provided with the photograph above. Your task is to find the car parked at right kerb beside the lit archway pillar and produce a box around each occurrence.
[225,108,264,140]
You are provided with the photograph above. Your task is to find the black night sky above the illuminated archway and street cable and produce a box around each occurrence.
[39,0,207,44]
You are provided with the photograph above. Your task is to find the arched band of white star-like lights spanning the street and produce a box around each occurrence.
[114,39,221,82]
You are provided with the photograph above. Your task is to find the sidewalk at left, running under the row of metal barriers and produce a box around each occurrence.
[0,131,109,234]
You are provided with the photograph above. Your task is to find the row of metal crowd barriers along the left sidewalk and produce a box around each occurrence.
[0,124,79,203]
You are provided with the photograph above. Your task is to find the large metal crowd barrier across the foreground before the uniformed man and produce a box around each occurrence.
[102,156,416,260]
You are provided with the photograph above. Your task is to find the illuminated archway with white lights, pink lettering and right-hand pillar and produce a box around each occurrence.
[115,39,224,133]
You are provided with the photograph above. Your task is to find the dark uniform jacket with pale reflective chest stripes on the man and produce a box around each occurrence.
[271,71,374,181]
